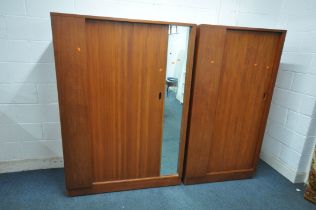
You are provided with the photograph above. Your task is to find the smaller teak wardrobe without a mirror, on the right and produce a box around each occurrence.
[184,25,285,184]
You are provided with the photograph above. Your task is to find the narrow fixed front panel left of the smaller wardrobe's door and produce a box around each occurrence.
[186,27,226,176]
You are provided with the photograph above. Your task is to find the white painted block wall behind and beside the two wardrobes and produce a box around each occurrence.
[0,0,316,182]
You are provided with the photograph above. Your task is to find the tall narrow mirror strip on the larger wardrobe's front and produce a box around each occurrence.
[160,25,190,175]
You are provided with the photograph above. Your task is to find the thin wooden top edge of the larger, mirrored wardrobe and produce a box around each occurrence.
[50,12,196,27]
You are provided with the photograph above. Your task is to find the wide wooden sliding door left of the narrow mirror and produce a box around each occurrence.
[86,20,168,182]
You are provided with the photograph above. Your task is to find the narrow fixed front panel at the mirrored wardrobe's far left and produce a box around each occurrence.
[51,15,92,189]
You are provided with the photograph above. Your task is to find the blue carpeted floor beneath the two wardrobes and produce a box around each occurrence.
[0,161,316,210]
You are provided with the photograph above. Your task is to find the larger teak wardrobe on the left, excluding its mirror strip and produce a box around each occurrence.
[51,13,195,195]
